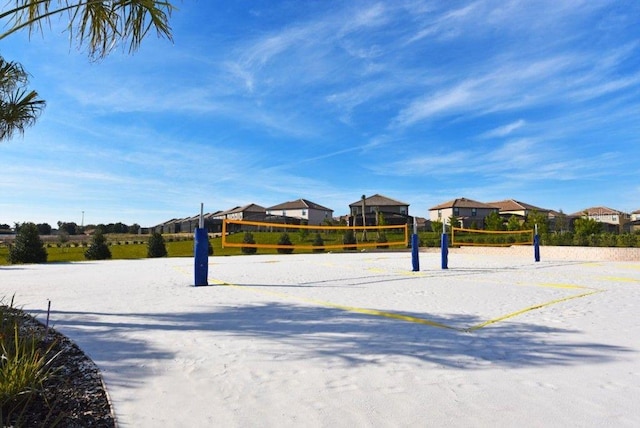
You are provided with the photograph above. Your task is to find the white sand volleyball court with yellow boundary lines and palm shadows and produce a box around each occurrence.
[0,252,640,428]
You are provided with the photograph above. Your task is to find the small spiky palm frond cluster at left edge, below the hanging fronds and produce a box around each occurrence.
[0,57,45,141]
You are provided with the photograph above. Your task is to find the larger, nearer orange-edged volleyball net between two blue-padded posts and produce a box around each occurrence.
[222,219,409,254]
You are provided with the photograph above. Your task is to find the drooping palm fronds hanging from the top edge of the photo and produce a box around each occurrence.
[0,0,174,59]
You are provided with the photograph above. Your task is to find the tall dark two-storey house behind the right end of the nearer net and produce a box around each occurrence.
[349,193,413,226]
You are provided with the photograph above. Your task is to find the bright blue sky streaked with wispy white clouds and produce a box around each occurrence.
[0,0,640,226]
